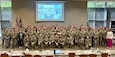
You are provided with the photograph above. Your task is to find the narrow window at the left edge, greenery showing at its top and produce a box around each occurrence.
[0,0,12,37]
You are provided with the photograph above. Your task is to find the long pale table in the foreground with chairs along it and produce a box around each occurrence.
[0,50,115,57]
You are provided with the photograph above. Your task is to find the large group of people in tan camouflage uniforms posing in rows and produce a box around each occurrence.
[2,25,108,49]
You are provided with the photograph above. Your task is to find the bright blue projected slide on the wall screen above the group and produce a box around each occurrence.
[36,3,64,21]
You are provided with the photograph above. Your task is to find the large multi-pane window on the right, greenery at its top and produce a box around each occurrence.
[87,1,115,28]
